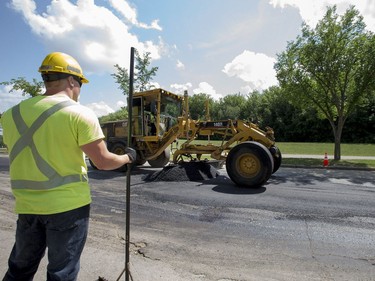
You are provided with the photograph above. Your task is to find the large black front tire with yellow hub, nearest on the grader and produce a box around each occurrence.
[226,141,274,187]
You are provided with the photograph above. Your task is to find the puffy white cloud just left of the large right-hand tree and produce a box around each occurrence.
[223,50,278,90]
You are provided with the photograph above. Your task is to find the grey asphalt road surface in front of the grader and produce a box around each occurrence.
[0,154,375,281]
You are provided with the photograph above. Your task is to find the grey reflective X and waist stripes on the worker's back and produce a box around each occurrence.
[9,101,88,190]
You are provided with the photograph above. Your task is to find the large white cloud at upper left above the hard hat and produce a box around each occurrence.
[12,0,163,72]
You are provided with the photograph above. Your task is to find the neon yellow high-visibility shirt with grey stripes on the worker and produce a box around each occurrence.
[1,95,104,214]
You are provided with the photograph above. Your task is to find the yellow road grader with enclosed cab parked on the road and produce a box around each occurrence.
[90,89,282,187]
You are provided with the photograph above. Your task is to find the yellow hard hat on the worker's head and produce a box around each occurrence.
[38,52,89,83]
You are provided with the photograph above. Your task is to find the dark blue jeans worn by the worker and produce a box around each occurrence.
[3,205,90,281]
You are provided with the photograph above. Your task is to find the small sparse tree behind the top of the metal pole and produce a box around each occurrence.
[111,50,159,96]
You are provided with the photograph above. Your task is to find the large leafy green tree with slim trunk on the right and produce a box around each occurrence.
[275,6,375,160]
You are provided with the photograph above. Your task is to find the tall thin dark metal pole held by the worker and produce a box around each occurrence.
[125,47,135,281]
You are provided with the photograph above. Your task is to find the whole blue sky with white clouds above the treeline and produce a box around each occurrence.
[0,0,375,117]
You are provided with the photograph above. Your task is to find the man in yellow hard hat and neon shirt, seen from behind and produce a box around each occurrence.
[1,52,136,281]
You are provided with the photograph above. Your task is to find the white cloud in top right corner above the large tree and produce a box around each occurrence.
[269,0,375,31]
